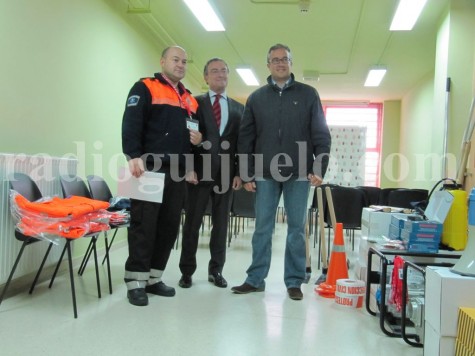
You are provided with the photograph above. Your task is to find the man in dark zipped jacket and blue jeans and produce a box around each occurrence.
[232,44,331,300]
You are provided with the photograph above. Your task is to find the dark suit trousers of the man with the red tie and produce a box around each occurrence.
[180,183,232,276]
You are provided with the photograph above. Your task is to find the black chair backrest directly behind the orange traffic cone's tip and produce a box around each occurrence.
[331,186,368,229]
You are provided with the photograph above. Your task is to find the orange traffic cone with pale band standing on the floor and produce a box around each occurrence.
[315,223,348,298]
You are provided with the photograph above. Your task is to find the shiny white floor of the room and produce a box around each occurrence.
[0,223,423,356]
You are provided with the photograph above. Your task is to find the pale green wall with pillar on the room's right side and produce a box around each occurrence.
[398,0,475,189]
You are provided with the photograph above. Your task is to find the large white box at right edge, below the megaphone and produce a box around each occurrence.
[424,266,475,336]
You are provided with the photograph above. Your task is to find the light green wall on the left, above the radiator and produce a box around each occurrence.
[0,0,199,256]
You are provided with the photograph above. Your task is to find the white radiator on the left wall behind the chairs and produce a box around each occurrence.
[0,153,78,285]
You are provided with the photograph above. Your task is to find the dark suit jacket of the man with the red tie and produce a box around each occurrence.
[194,92,244,184]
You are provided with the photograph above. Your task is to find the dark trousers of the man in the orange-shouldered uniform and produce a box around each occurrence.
[125,177,185,272]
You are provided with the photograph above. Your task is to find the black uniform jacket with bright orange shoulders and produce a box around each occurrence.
[122,73,198,170]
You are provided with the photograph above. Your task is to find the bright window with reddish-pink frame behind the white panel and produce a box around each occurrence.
[323,104,383,187]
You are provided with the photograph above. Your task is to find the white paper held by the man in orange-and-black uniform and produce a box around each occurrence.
[117,167,165,203]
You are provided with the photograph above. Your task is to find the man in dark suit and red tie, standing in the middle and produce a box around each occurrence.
[178,58,244,288]
